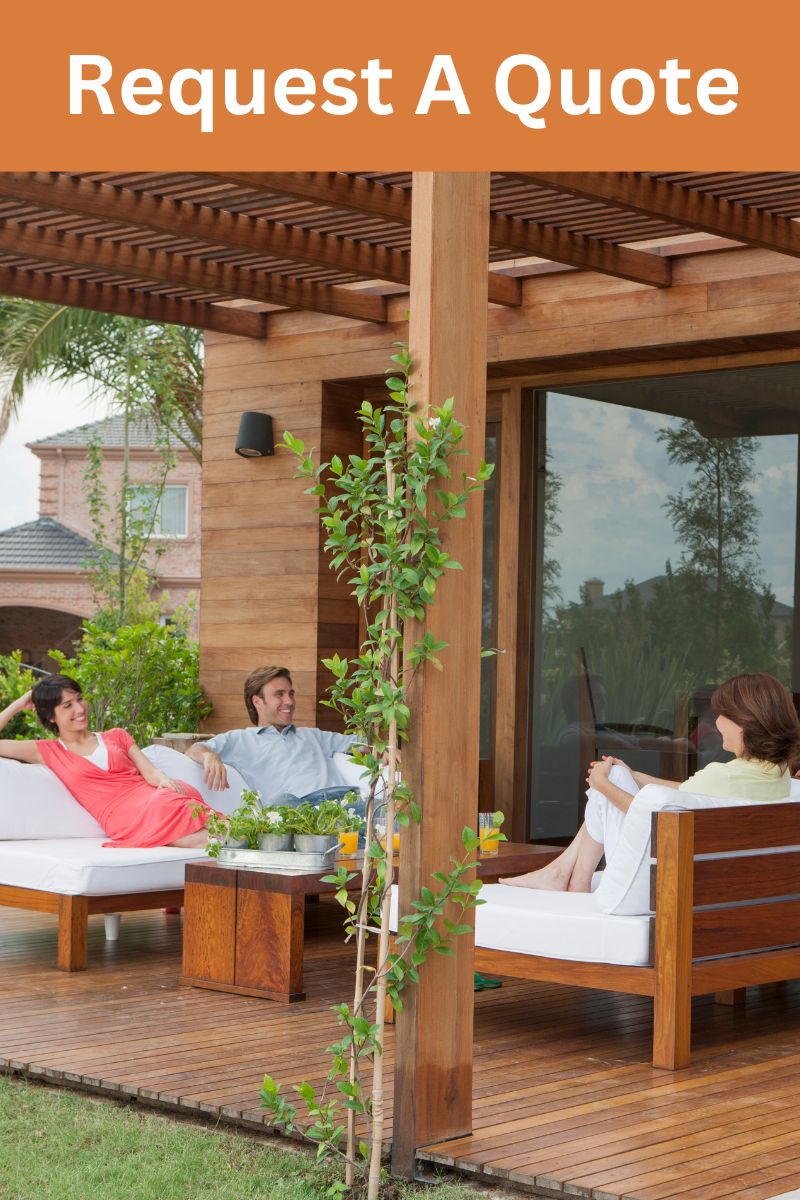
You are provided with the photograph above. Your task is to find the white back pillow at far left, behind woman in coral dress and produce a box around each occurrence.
[0,758,104,841]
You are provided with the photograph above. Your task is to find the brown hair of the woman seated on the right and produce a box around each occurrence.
[711,674,800,767]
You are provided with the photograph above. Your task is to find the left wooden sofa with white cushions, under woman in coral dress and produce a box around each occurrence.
[0,746,245,971]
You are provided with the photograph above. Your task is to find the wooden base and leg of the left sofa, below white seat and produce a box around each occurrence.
[0,884,184,971]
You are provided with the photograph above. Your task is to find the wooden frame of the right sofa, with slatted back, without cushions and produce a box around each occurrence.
[475,804,800,1070]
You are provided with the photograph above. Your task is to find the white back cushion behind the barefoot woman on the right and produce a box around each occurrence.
[595,784,794,914]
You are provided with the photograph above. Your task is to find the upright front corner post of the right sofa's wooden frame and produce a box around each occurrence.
[652,812,694,1070]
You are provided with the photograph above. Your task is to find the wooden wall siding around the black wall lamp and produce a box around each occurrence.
[200,352,321,730]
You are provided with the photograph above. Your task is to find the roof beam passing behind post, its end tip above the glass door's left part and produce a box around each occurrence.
[213,172,672,289]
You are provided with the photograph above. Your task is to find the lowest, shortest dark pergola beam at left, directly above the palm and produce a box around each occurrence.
[0,265,266,338]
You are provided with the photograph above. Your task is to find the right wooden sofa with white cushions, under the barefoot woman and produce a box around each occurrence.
[392,782,800,1069]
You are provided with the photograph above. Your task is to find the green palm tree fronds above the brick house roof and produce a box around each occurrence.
[0,296,203,462]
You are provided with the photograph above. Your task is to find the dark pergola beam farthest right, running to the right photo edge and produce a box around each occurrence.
[513,172,800,257]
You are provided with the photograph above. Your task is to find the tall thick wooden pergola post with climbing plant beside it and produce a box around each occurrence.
[392,173,489,1177]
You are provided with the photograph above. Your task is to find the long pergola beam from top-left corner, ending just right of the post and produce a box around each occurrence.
[0,172,532,305]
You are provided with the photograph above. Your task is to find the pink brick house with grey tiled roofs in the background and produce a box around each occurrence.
[0,416,200,666]
